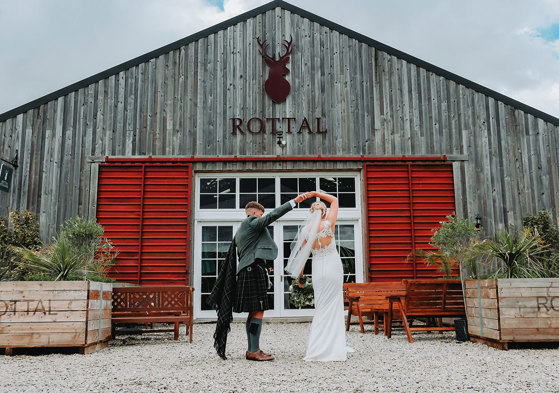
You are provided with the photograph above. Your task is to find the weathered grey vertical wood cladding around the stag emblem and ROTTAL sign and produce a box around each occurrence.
[0,8,559,239]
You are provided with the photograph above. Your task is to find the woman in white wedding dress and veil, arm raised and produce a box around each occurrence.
[285,191,353,361]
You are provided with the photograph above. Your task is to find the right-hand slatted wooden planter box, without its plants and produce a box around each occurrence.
[464,278,559,349]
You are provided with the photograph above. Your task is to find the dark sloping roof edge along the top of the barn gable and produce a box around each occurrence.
[0,0,559,126]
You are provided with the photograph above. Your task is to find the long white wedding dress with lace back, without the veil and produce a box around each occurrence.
[304,220,353,361]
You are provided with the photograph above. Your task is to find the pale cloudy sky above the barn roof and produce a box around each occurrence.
[0,0,559,118]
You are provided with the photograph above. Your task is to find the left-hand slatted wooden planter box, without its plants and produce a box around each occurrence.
[0,281,112,355]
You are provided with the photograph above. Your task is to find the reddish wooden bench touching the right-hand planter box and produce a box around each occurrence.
[386,279,466,343]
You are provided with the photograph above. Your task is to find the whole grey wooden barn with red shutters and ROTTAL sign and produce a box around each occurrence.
[0,0,559,318]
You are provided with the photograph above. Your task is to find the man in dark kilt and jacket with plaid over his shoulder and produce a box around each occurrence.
[210,194,308,361]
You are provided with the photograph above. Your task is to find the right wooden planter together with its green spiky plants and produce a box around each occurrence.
[465,212,559,349]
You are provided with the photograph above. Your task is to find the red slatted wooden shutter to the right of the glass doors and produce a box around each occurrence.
[365,163,455,281]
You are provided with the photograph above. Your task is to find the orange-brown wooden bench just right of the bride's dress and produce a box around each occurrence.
[344,282,404,334]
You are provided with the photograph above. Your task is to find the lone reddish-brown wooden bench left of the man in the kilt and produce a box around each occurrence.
[111,286,194,342]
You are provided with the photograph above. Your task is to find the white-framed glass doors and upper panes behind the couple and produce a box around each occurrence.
[192,173,363,318]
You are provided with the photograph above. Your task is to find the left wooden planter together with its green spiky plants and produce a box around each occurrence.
[0,213,114,354]
